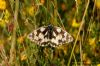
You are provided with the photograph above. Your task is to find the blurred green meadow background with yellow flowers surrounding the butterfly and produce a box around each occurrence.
[0,0,100,66]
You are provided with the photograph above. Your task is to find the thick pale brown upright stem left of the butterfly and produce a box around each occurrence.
[9,0,19,66]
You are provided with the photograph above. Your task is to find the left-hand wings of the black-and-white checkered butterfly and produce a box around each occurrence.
[28,27,48,46]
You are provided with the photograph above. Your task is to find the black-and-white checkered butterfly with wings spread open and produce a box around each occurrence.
[27,25,73,47]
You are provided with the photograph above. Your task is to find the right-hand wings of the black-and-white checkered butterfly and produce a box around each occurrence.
[51,27,73,46]
